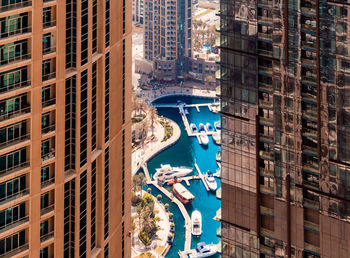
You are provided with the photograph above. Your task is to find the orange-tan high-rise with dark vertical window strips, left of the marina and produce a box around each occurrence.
[0,0,131,257]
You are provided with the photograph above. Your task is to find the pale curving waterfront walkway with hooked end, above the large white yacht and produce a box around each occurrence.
[132,119,181,175]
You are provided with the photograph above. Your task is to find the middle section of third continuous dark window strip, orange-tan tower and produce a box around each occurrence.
[91,63,97,151]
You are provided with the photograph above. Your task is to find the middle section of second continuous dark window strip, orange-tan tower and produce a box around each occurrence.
[80,70,88,167]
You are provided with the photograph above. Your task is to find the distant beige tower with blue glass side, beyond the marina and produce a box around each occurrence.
[143,0,192,81]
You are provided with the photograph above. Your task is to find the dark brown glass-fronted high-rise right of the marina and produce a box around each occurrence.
[220,0,350,257]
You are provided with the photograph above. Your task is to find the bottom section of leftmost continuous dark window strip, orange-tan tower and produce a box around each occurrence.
[64,179,75,258]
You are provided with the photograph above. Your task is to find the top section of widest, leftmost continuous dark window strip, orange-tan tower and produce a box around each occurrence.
[66,0,77,68]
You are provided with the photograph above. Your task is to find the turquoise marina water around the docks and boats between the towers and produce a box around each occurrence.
[148,96,221,257]
